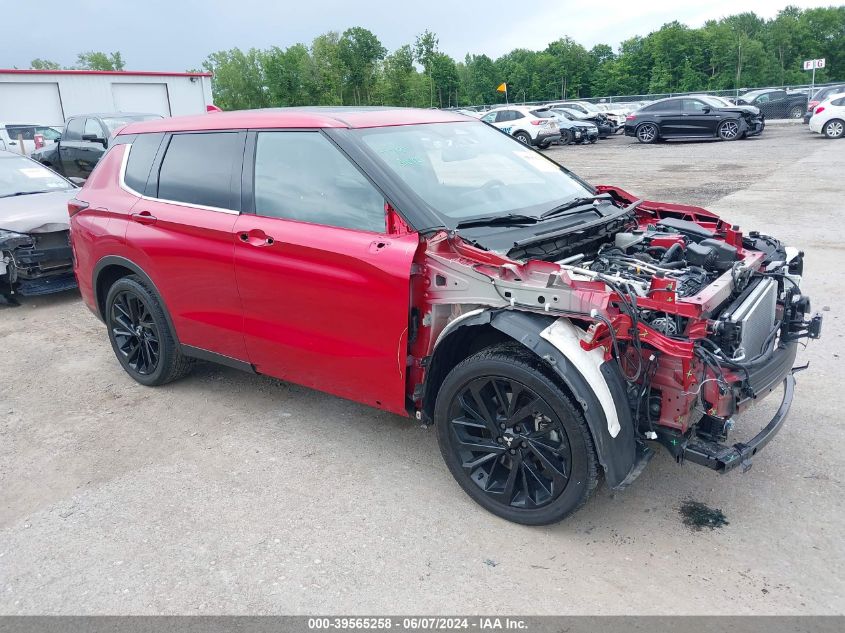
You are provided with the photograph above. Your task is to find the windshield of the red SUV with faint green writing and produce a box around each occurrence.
[354,122,593,228]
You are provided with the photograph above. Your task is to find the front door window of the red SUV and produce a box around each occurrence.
[255,132,385,233]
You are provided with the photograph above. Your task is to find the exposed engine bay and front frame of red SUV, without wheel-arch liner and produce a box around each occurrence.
[409,187,821,482]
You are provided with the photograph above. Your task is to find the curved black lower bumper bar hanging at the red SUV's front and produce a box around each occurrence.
[681,373,795,473]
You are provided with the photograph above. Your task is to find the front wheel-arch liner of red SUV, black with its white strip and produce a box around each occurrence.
[433,310,642,488]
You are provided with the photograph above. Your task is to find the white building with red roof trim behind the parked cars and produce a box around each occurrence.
[0,69,212,125]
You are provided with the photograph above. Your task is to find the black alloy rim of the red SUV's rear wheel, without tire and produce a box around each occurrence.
[109,290,161,376]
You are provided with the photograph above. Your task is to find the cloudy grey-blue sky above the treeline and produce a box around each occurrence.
[0,0,835,71]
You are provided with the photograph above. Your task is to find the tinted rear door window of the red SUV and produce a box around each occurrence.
[157,132,241,209]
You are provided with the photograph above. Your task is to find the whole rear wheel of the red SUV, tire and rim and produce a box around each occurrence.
[103,275,193,387]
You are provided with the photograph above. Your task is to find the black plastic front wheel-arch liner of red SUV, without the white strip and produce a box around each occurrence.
[435,310,643,488]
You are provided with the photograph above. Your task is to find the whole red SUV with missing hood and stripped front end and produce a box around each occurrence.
[69,108,821,524]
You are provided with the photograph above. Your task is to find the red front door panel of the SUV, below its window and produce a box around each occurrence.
[235,215,419,414]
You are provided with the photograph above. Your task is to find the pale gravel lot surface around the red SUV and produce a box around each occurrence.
[0,125,845,614]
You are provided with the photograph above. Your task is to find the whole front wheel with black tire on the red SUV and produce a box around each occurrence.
[434,344,599,525]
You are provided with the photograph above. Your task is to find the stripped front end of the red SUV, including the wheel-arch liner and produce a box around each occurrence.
[408,187,821,488]
